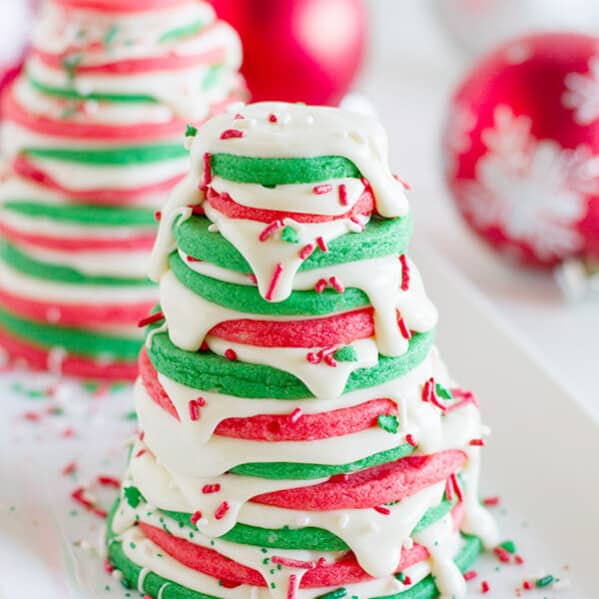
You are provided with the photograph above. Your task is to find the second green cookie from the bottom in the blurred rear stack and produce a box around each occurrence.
[0,242,153,287]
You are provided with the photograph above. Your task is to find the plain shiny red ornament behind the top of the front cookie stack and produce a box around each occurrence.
[212,0,365,105]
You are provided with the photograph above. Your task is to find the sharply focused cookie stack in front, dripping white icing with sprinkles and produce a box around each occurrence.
[107,103,497,599]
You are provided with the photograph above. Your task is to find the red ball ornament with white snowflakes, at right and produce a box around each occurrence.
[444,33,599,266]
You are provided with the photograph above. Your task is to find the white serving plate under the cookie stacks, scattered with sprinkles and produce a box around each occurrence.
[0,241,599,599]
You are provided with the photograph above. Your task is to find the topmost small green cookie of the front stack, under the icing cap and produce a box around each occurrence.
[210,154,362,187]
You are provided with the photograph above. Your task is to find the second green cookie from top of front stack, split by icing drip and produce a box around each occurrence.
[174,215,413,273]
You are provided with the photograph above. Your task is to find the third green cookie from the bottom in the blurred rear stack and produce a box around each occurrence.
[2,199,155,228]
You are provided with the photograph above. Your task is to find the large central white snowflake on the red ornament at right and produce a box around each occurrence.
[459,105,599,260]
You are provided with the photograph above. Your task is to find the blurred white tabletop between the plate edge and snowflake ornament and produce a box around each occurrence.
[357,0,599,419]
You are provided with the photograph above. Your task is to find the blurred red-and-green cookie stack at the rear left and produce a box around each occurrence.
[0,0,246,379]
